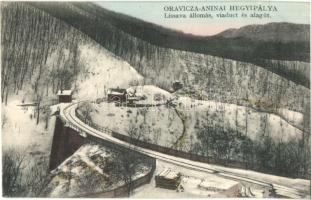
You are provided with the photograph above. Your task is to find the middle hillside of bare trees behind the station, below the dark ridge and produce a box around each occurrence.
[26,3,309,112]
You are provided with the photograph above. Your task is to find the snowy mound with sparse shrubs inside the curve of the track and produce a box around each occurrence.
[78,85,184,147]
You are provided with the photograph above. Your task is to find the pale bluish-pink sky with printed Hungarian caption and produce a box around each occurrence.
[96,1,310,35]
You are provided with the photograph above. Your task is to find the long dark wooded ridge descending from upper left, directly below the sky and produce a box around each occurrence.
[28,2,310,87]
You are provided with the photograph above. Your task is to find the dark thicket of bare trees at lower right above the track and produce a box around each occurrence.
[191,117,311,179]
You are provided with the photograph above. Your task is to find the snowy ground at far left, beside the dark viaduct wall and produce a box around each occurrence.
[1,93,56,196]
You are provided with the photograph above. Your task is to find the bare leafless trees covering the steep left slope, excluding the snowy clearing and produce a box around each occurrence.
[1,3,87,104]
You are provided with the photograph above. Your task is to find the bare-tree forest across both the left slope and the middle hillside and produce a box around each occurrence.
[1,3,309,112]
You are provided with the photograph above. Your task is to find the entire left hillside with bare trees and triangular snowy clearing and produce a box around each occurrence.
[1,3,143,102]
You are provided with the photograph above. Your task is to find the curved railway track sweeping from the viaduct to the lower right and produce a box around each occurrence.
[60,102,307,199]
